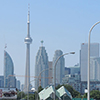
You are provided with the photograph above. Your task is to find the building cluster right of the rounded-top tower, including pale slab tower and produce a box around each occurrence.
[63,43,100,94]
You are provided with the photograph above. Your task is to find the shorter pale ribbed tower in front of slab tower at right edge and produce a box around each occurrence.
[90,57,100,81]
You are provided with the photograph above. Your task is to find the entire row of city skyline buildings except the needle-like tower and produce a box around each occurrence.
[0,41,100,94]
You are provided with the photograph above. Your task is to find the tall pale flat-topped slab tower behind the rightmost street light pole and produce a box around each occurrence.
[80,43,99,81]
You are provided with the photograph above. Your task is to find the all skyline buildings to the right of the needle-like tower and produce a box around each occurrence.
[35,43,100,94]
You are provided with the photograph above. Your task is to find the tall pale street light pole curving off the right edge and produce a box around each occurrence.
[87,21,100,100]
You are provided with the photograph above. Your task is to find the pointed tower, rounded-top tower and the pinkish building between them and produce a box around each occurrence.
[35,45,65,89]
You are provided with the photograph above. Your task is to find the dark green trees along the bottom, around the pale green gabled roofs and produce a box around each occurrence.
[17,84,100,100]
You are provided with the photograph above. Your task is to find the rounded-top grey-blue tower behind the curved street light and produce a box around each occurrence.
[53,50,65,84]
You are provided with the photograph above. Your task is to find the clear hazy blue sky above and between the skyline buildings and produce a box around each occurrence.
[0,0,100,86]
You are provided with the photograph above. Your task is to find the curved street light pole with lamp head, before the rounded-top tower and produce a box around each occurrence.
[54,52,75,100]
